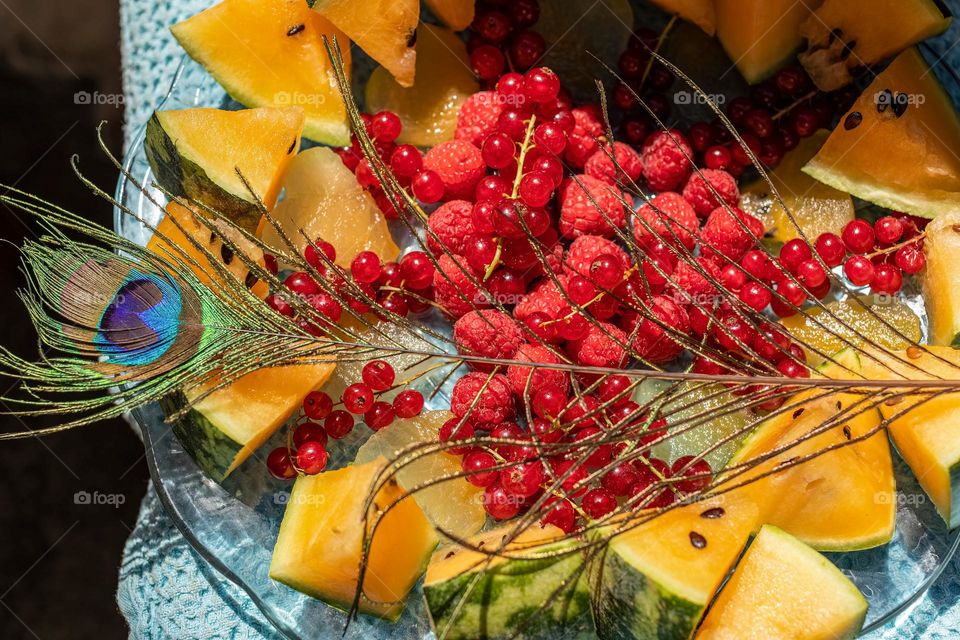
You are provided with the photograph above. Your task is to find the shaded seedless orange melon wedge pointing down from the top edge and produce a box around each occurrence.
[715,0,819,84]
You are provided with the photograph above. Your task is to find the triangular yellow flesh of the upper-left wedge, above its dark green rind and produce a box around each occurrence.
[157,107,304,209]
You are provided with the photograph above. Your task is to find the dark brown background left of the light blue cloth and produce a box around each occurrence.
[0,0,147,640]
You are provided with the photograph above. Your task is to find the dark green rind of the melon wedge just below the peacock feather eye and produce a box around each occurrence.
[160,392,244,482]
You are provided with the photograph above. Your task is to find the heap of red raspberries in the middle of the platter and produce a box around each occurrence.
[424,92,764,429]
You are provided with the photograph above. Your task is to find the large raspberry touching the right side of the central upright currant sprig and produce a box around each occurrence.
[560,176,626,237]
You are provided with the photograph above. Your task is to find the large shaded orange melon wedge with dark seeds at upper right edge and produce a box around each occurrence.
[803,48,960,218]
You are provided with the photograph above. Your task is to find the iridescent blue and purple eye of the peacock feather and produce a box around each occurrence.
[94,269,183,366]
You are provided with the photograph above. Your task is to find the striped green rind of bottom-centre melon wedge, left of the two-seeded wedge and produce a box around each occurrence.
[423,542,592,640]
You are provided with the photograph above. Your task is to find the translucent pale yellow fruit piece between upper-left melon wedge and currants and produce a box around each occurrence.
[263,147,399,268]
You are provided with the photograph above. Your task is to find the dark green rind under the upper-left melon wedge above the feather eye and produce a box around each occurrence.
[144,112,261,233]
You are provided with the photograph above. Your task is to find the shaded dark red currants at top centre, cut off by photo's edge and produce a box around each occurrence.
[467,0,547,85]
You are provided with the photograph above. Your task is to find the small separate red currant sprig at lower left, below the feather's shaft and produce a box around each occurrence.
[267,360,424,480]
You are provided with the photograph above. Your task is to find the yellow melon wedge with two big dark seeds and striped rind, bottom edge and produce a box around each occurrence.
[592,491,761,640]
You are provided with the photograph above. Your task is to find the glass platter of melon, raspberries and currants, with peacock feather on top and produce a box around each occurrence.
[0,0,960,640]
